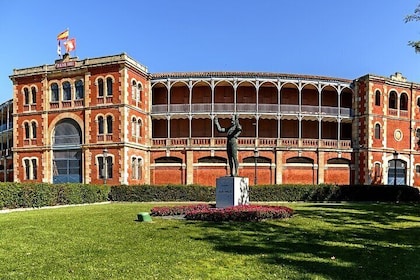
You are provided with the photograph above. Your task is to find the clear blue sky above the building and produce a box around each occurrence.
[0,0,420,102]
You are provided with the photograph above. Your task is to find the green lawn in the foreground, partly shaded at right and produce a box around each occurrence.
[0,203,420,280]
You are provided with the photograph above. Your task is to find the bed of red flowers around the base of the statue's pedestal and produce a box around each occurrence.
[151,204,293,222]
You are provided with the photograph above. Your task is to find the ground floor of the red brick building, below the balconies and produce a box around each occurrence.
[9,145,420,186]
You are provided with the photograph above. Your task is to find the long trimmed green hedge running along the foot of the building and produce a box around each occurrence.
[0,183,420,209]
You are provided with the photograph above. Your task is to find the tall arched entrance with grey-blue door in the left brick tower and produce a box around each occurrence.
[52,119,82,184]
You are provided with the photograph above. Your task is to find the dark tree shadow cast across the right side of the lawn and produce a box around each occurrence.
[191,203,420,279]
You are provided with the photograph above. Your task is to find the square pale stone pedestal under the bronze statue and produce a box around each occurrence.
[216,176,249,208]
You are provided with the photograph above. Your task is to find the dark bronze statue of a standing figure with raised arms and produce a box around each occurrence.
[214,115,242,177]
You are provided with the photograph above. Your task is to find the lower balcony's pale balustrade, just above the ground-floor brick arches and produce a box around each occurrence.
[152,137,351,150]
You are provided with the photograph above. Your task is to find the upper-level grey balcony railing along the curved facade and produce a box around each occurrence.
[152,103,353,117]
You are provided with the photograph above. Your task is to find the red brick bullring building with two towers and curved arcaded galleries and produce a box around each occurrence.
[0,54,420,186]
